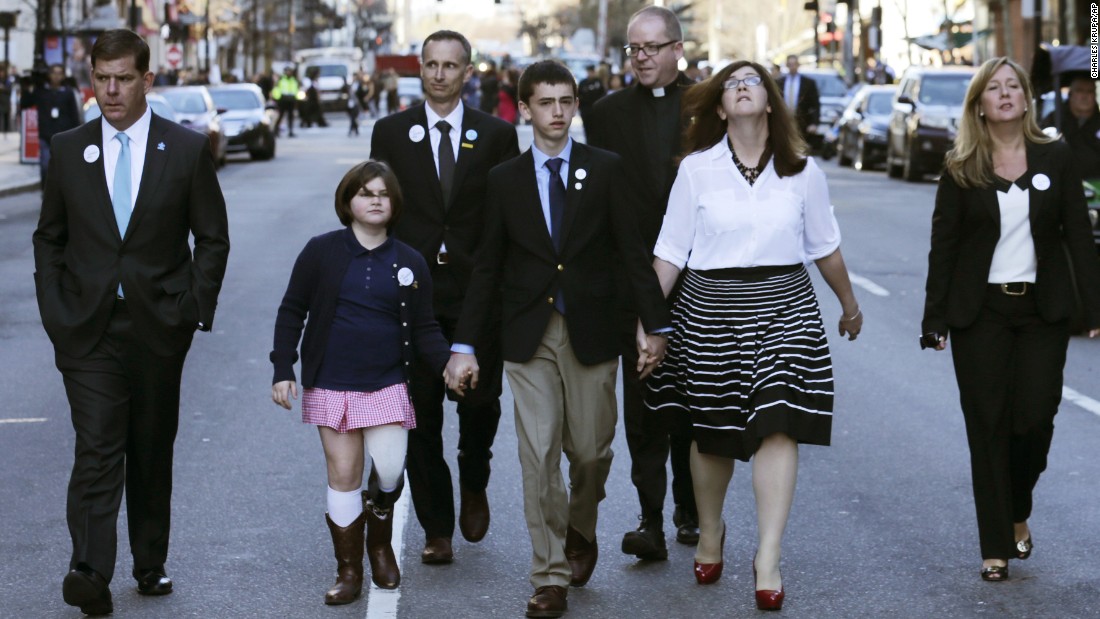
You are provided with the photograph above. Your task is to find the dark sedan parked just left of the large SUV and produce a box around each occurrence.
[837,86,898,170]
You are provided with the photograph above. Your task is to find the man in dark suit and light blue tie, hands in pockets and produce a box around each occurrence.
[33,30,229,615]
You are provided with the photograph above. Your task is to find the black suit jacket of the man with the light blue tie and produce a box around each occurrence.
[33,114,229,357]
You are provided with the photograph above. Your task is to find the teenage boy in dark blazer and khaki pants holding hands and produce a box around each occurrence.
[446,60,671,617]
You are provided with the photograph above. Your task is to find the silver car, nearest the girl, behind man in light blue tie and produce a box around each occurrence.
[209,84,275,159]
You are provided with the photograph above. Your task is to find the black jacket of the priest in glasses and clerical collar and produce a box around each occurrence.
[584,74,693,250]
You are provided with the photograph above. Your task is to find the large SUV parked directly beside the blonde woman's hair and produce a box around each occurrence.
[887,66,977,183]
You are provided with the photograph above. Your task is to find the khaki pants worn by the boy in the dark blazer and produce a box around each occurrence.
[504,312,618,588]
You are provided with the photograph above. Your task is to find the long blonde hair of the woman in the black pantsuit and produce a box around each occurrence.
[944,56,1054,188]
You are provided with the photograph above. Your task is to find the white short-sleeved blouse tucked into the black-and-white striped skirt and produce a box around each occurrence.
[653,137,840,270]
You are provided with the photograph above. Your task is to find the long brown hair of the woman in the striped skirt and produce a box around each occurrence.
[681,60,810,177]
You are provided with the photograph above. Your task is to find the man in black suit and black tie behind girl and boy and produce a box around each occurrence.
[371,30,519,564]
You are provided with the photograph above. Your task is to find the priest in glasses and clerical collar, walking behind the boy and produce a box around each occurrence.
[584,2,699,561]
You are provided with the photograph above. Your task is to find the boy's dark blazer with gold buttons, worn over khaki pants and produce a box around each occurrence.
[454,142,671,365]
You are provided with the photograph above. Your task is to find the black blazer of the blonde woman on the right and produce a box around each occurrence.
[921,142,1100,334]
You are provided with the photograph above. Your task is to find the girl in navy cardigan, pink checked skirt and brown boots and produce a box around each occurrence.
[271,161,450,605]
